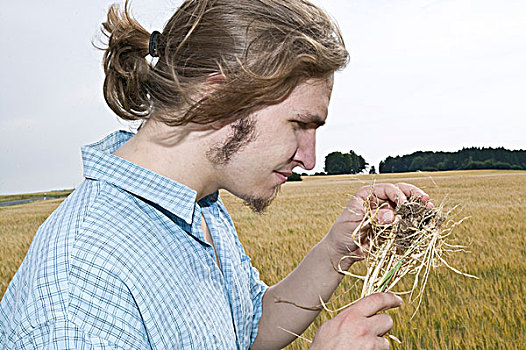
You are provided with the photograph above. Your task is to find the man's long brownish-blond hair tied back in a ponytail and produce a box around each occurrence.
[102,0,348,126]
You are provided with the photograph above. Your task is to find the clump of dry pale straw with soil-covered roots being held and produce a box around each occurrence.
[334,189,477,316]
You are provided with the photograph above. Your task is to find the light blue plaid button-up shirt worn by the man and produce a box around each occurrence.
[0,131,267,349]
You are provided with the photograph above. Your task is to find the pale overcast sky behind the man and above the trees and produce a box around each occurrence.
[0,0,526,194]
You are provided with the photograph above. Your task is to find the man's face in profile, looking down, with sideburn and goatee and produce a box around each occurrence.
[211,77,333,212]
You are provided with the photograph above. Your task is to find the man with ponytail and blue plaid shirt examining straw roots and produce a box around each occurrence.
[0,0,428,349]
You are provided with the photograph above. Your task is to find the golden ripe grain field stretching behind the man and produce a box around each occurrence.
[0,170,526,350]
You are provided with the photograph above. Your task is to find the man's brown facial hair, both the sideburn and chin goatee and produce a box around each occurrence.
[206,117,281,214]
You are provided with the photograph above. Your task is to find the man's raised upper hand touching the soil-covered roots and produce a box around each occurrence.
[327,183,433,269]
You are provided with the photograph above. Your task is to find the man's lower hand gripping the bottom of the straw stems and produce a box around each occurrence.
[310,293,402,350]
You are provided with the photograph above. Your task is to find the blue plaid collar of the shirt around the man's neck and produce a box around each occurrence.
[82,130,218,225]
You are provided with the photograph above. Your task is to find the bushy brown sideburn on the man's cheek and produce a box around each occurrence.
[206,117,256,166]
